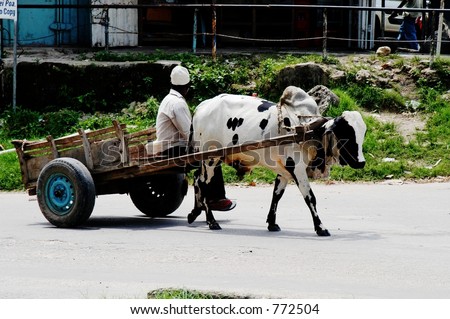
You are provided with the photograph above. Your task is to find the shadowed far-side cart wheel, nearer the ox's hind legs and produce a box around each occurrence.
[130,173,188,217]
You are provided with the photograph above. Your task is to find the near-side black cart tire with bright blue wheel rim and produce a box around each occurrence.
[37,157,95,227]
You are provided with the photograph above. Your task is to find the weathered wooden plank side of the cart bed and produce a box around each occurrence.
[12,121,156,195]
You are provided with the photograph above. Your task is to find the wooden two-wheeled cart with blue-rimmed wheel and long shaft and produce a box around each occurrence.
[12,121,323,227]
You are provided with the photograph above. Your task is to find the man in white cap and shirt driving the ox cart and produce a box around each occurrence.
[155,65,236,211]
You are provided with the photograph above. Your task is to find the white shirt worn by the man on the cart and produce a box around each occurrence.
[156,89,192,150]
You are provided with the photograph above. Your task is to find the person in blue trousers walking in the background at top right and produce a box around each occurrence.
[393,0,423,51]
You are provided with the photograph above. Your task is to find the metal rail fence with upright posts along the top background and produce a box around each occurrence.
[1,1,450,57]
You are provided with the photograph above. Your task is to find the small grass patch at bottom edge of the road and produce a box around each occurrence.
[147,288,251,299]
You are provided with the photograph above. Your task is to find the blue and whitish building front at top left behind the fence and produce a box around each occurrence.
[1,0,138,47]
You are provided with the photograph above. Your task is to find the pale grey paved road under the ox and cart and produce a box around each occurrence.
[0,183,450,298]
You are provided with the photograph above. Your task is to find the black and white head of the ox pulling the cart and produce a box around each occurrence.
[324,111,367,168]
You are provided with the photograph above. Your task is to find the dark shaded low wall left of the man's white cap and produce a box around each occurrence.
[0,61,179,112]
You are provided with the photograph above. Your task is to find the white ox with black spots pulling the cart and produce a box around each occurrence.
[188,86,366,236]
